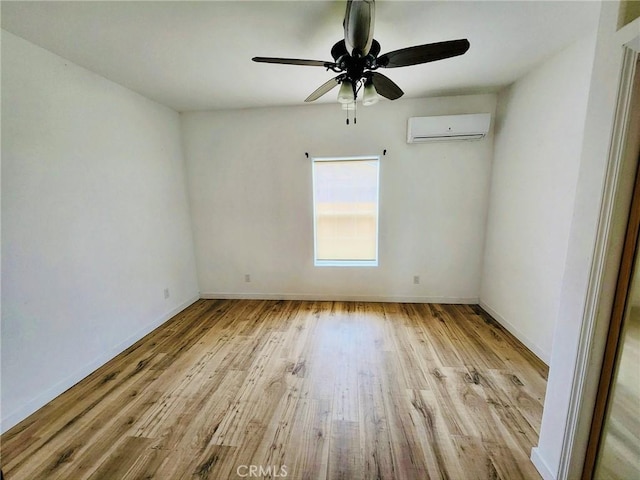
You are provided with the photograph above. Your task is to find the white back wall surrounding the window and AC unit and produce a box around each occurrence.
[182,95,496,302]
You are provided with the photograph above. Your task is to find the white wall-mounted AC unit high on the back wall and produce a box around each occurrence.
[407,113,491,143]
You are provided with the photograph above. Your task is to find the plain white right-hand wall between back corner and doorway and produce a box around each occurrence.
[480,32,595,364]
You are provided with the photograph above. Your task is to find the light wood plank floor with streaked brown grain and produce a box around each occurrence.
[1,300,547,480]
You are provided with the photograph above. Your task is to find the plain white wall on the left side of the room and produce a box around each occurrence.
[2,31,198,430]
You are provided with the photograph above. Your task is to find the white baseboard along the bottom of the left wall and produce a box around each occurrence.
[0,295,200,433]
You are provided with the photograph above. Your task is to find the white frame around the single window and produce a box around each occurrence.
[311,155,381,267]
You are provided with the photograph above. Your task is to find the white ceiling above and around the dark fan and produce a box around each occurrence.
[1,0,599,111]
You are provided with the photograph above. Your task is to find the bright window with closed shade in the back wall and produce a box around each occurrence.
[313,157,380,266]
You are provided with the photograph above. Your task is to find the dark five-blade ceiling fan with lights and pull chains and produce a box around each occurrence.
[252,0,469,123]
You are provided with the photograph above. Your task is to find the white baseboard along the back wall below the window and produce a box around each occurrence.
[200,292,479,305]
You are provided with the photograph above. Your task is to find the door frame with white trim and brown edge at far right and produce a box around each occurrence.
[556,30,640,480]
